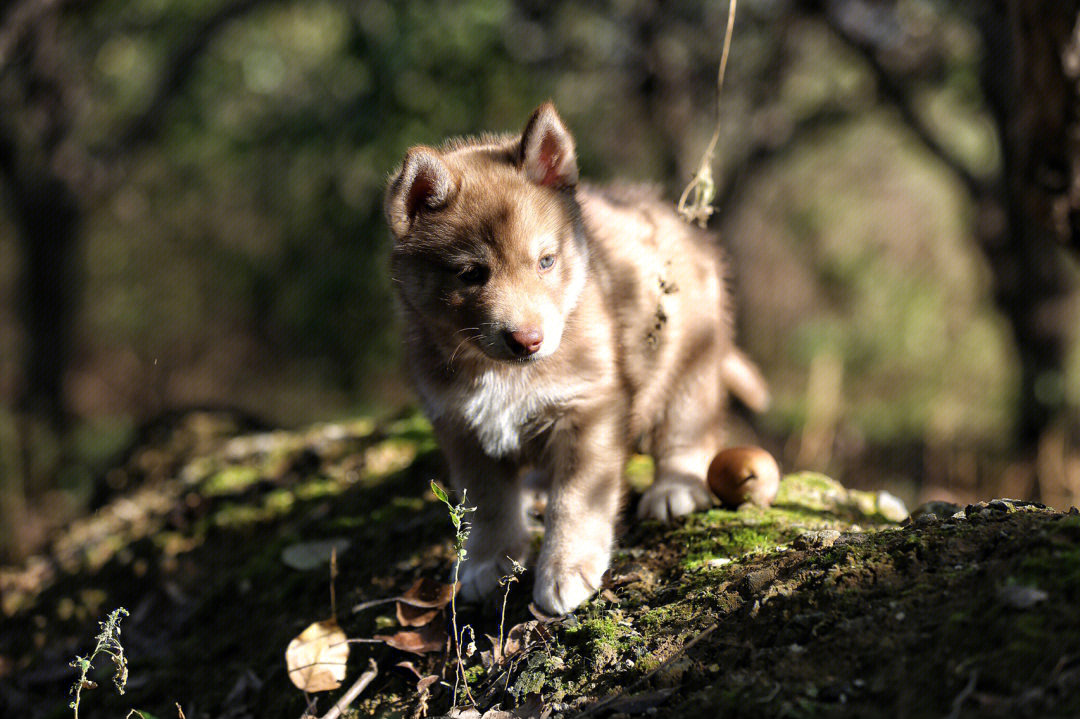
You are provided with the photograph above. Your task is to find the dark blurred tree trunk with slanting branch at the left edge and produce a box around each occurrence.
[0,0,271,556]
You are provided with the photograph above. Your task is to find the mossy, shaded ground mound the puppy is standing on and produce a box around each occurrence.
[0,415,1080,719]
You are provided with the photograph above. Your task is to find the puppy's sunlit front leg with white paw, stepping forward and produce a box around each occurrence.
[532,408,626,615]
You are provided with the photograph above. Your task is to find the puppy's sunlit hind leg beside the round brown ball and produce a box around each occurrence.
[637,353,725,521]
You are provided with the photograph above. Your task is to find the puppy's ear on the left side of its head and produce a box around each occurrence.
[384,147,456,238]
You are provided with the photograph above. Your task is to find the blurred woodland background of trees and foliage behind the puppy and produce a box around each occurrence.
[0,0,1080,554]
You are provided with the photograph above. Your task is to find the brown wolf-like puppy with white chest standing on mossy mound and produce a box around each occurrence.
[386,104,764,614]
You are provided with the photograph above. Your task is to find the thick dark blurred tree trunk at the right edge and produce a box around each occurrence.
[976,0,1080,464]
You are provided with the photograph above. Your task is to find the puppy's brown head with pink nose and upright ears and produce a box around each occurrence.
[386,103,588,362]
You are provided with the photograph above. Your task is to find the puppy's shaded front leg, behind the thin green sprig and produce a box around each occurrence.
[441,433,529,601]
